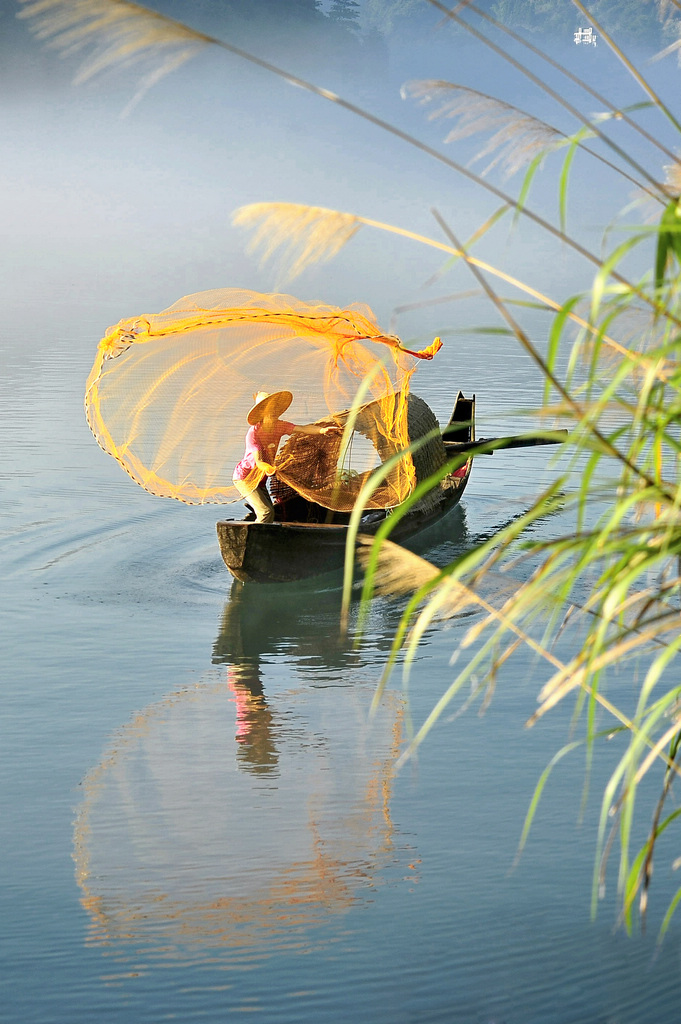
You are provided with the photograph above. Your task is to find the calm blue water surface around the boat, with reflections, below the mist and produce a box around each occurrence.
[5,315,679,1024]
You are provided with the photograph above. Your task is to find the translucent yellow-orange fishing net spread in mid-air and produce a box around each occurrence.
[85,289,440,511]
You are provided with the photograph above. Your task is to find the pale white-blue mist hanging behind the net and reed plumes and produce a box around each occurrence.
[0,0,662,369]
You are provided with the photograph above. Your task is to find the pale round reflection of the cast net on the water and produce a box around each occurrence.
[74,675,401,964]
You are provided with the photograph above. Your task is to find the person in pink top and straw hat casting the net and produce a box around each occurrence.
[233,391,340,522]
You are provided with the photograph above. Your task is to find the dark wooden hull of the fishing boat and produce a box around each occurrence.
[217,392,475,583]
